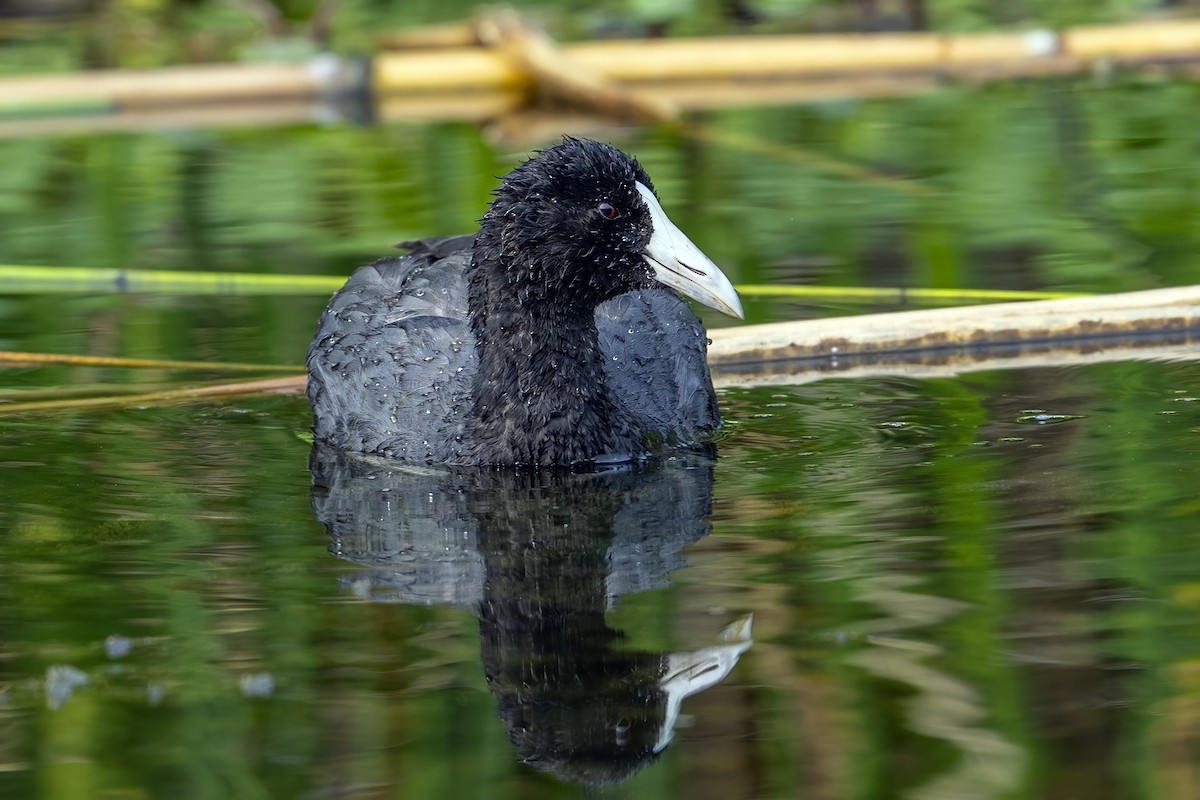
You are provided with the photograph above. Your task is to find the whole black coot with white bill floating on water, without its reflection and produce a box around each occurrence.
[308,138,742,464]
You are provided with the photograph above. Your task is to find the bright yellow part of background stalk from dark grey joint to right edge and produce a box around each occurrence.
[374,19,1200,92]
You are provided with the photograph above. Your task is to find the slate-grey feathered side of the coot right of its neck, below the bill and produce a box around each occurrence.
[596,289,721,444]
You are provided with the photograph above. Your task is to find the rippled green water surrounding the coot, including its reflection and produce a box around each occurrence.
[0,84,1200,800]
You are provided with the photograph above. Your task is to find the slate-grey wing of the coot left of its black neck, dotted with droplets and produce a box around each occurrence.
[308,247,476,462]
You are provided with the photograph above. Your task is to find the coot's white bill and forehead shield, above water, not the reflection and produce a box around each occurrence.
[634,181,745,319]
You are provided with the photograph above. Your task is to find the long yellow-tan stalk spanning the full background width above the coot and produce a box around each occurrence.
[0,17,1200,115]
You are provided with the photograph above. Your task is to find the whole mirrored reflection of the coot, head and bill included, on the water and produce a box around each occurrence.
[311,444,750,784]
